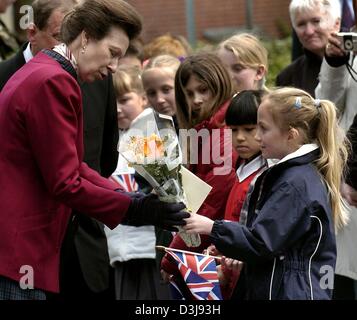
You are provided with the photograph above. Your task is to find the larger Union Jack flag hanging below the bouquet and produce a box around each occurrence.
[166,250,222,300]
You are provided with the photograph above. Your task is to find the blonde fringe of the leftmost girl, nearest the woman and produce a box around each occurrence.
[113,65,144,97]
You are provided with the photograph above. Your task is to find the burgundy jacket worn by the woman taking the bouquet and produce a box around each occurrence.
[0,53,130,292]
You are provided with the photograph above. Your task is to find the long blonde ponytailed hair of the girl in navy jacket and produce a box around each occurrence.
[264,88,349,230]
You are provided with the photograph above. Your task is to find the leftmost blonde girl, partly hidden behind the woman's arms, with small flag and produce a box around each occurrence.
[104,65,168,300]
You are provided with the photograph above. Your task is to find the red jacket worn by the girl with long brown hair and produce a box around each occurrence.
[161,101,238,274]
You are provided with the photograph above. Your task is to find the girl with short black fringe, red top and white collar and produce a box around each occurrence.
[207,90,267,299]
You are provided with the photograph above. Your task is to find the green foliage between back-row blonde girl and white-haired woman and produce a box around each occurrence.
[264,37,291,88]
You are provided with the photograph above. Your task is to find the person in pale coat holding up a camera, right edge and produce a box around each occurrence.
[315,23,357,299]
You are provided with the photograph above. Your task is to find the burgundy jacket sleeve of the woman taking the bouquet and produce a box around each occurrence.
[26,75,131,228]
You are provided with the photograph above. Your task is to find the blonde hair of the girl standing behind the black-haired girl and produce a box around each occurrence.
[218,33,269,89]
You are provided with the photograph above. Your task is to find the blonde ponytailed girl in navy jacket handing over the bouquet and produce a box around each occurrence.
[185,88,347,300]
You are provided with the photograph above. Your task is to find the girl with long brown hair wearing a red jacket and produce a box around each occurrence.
[161,53,237,298]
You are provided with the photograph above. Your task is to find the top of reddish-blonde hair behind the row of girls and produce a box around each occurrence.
[143,34,191,59]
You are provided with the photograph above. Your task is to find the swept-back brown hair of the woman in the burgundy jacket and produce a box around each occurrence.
[61,0,142,44]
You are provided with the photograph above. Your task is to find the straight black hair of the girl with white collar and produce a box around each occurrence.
[225,90,266,126]
